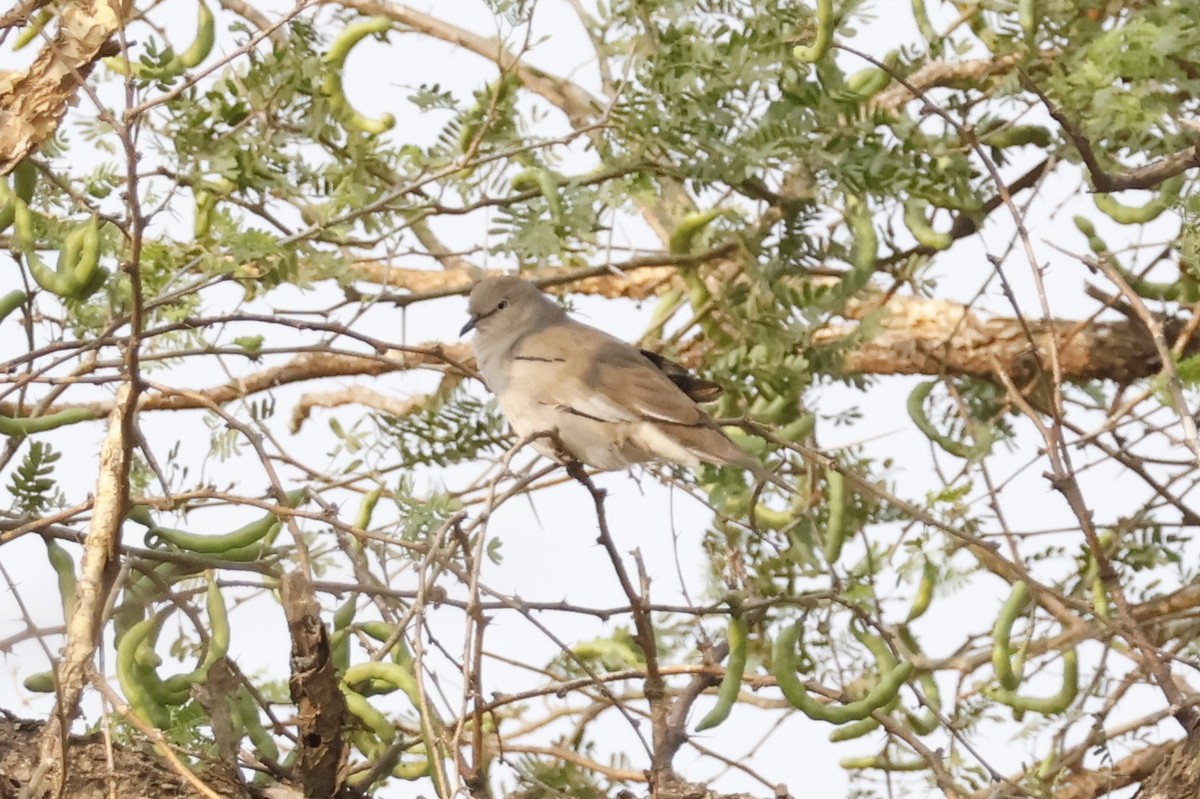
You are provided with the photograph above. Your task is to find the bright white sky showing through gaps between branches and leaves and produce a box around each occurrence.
[0,0,1177,798]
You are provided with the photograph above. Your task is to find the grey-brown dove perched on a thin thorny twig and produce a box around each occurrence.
[462,276,793,491]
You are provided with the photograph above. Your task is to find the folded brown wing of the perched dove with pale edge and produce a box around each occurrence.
[514,325,708,426]
